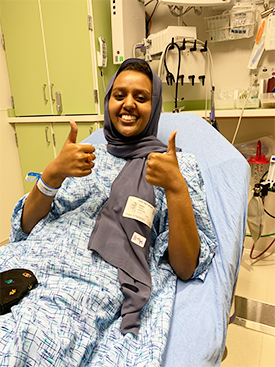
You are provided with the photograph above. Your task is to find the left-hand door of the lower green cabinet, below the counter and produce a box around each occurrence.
[15,123,54,192]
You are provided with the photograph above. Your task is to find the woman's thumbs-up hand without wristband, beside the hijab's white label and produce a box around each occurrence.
[146,130,183,190]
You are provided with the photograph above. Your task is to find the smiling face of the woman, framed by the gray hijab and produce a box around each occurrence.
[109,70,152,137]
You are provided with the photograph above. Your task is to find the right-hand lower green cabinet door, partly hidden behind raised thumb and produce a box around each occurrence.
[53,122,97,155]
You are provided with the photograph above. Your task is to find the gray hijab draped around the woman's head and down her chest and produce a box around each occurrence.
[88,59,167,336]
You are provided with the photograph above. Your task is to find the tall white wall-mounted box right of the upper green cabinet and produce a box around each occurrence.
[110,0,146,64]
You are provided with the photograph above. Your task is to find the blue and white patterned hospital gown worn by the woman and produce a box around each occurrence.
[0,144,216,367]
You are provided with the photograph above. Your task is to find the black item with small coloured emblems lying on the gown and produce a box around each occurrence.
[0,269,38,315]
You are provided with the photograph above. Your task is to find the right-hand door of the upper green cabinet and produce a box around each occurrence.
[41,0,96,115]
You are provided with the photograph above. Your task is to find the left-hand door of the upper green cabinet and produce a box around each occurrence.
[0,0,52,116]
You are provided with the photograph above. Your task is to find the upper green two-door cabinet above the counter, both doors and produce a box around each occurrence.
[0,0,97,116]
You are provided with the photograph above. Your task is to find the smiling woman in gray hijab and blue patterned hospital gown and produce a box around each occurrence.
[0,59,216,366]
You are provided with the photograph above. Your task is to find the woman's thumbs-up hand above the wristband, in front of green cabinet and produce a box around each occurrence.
[43,120,95,187]
